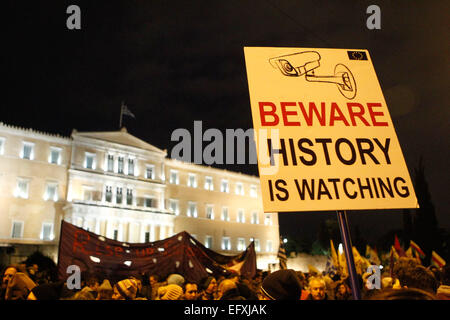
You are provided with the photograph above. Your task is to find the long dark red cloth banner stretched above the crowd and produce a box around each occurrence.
[58,221,256,282]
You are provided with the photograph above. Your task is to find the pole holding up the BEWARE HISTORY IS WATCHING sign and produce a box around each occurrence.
[337,210,361,300]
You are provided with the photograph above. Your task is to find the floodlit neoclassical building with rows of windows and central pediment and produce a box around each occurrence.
[0,123,279,269]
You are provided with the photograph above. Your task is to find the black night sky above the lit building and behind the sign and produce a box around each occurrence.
[0,0,450,245]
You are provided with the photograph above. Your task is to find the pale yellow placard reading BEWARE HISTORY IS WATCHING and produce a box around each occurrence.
[244,47,418,212]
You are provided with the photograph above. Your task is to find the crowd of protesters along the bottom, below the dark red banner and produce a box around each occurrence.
[0,258,450,300]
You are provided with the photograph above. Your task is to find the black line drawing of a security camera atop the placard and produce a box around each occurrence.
[269,51,356,100]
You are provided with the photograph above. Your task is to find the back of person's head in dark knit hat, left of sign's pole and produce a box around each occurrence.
[261,269,302,300]
